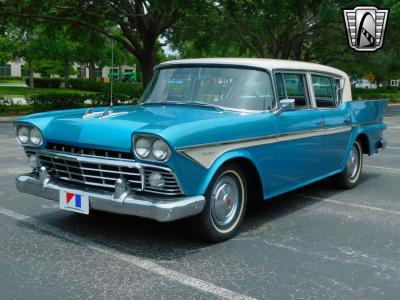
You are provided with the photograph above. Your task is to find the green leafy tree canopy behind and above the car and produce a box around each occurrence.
[0,0,400,84]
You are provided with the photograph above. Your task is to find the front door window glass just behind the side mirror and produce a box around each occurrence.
[275,73,310,109]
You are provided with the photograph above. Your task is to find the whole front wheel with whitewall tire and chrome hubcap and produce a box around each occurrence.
[191,164,247,242]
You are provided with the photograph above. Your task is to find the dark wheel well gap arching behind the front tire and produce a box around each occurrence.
[220,158,263,202]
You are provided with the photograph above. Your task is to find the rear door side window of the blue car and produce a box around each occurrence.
[311,75,339,107]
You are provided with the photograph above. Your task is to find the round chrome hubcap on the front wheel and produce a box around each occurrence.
[211,175,241,227]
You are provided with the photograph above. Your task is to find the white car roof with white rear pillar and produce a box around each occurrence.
[159,58,352,101]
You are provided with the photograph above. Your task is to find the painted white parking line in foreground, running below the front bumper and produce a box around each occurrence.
[0,207,255,300]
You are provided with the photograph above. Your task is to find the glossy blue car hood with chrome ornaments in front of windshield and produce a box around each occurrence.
[17,104,241,151]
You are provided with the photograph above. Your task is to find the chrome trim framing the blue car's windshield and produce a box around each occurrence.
[138,63,278,113]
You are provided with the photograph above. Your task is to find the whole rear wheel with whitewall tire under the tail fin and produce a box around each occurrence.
[335,140,363,189]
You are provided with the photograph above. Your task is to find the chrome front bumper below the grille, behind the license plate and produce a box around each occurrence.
[16,173,205,222]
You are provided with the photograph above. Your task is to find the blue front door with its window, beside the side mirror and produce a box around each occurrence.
[274,71,324,188]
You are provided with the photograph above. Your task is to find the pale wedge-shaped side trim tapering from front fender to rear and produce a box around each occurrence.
[176,126,352,169]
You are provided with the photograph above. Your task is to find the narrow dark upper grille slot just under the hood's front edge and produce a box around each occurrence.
[46,143,134,160]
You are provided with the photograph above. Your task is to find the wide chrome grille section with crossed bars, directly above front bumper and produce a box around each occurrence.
[39,154,142,190]
